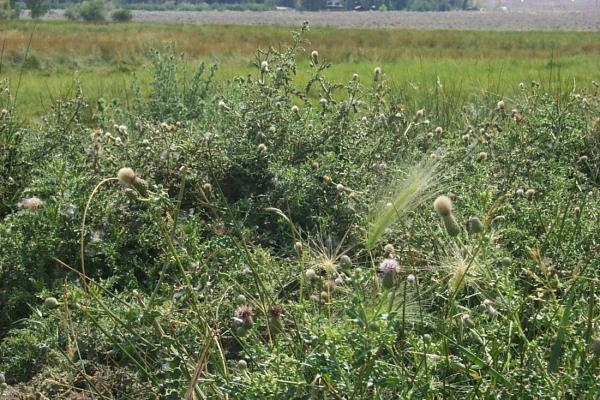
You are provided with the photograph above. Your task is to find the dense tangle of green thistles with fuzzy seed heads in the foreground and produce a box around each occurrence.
[0,25,600,399]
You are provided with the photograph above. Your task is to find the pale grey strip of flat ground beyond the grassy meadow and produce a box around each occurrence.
[36,0,600,31]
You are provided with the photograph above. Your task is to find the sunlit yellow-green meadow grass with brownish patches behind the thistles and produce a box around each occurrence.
[0,21,600,116]
